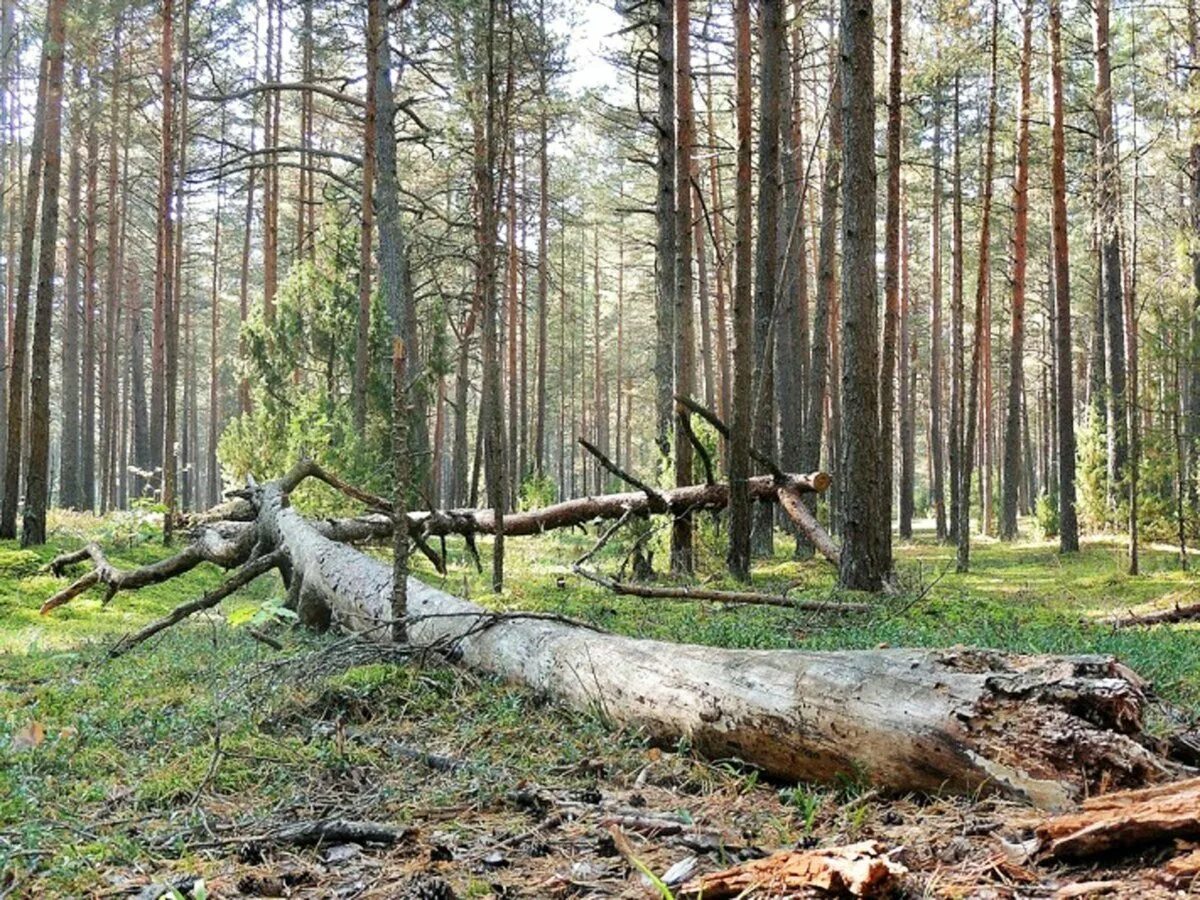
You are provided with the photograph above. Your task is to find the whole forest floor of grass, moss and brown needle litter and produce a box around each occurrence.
[0,504,1200,898]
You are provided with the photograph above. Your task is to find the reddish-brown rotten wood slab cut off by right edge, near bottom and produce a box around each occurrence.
[1038,778,1200,859]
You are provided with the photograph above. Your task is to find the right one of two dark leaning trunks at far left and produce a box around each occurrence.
[20,0,66,546]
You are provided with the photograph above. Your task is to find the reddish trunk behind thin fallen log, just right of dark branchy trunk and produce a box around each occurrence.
[671,0,696,575]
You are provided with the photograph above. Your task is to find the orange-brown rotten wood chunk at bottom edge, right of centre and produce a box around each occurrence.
[682,841,908,900]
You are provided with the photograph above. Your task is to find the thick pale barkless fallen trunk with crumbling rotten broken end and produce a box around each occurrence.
[46,464,1169,808]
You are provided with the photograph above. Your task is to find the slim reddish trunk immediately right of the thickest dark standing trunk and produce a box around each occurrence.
[878,0,904,561]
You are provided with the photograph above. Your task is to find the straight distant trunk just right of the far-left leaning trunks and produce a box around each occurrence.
[59,60,84,509]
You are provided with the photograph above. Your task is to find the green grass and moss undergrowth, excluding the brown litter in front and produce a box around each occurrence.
[0,508,1200,896]
